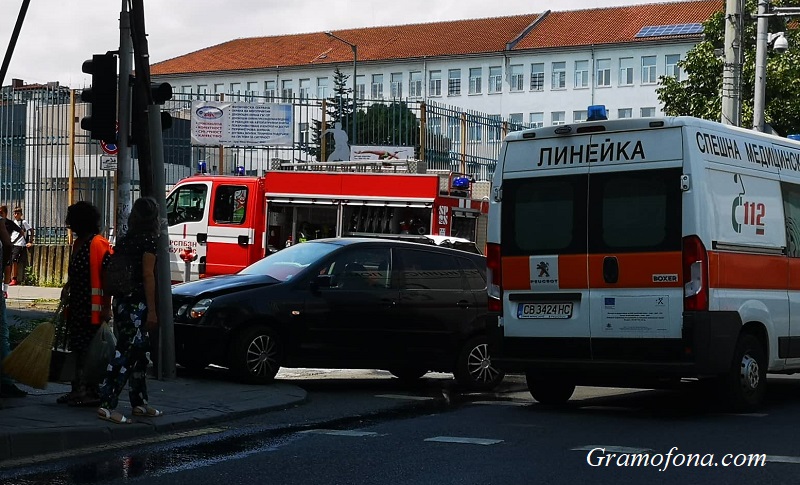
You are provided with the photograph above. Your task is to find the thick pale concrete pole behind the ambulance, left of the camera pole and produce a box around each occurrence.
[720,0,744,126]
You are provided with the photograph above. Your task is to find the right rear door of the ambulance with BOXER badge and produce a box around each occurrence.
[586,123,683,361]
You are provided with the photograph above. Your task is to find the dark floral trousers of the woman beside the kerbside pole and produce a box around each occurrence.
[100,299,150,409]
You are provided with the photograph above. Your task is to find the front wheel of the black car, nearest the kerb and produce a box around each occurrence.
[228,325,281,384]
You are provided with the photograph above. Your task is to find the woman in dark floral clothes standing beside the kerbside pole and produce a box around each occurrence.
[97,197,162,424]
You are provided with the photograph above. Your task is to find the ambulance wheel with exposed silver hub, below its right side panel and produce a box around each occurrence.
[722,333,767,412]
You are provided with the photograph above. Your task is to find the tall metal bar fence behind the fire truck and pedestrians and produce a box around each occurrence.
[0,83,523,244]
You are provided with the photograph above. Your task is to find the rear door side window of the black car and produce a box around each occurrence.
[397,249,464,290]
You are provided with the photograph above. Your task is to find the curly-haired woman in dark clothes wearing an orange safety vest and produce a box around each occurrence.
[57,201,111,406]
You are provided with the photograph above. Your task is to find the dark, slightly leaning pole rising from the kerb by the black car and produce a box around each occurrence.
[131,0,175,379]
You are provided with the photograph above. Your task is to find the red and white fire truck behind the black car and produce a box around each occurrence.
[167,161,489,282]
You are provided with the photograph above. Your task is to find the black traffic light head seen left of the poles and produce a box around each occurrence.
[81,53,117,143]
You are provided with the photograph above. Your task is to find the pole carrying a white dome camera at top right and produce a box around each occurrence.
[753,0,800,132]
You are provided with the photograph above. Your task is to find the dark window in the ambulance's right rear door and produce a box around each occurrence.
[588,168,681,253]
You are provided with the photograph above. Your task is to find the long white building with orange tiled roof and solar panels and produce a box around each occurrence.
[151,0,725,125]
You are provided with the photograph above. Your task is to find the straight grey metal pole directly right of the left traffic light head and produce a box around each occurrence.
[114,0,133,238]
